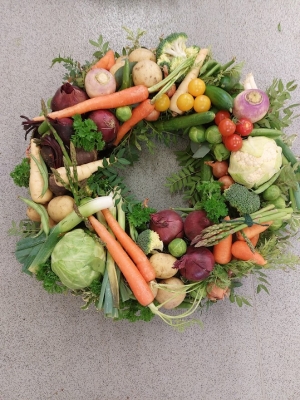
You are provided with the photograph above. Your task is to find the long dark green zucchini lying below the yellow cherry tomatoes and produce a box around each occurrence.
[150,111,215,132]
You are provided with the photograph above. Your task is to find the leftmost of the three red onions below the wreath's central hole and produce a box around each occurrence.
[150,210,184,246]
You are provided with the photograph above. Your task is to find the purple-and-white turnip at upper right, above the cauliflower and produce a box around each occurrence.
[232,89,270,123]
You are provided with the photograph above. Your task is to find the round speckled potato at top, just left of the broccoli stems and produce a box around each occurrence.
[132,60,163,88]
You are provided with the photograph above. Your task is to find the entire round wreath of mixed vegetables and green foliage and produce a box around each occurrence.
[10,28,300,329]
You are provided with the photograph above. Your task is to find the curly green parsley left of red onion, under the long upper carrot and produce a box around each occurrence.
[71,114,105,151]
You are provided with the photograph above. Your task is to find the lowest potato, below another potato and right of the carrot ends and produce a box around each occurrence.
[155,277,186,310]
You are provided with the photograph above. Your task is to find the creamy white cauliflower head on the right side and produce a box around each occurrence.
[228,136,282,189]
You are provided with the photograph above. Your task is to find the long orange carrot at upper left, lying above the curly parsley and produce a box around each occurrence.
[33,85,149,121]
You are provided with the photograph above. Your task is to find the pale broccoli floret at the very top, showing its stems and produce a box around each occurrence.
[156,32,200,72]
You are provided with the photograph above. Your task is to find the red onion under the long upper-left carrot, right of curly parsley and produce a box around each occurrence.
[88,110,120,144]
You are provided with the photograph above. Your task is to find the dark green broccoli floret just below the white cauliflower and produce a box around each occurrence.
[224,183,260,214]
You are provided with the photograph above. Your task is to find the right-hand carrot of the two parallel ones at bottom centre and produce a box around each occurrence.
[102,209,155,282]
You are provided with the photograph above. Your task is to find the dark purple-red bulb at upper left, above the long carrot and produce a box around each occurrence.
[50,82,89,111]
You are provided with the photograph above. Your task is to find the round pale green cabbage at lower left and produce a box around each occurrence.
[51,229,106,289]
